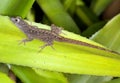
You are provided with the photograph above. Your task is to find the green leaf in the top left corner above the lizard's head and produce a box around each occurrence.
[0,0,35,18]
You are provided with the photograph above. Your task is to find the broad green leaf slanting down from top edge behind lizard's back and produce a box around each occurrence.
[37,0,80,33]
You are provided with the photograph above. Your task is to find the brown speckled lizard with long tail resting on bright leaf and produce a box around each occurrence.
[10,16,119,54]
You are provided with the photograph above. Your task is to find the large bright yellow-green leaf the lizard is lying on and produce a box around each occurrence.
[0,16,120,76]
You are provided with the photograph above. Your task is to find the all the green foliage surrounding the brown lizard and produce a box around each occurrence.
[0,0,120,83]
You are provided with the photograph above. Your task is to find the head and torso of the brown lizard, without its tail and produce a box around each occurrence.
[11,17,61,42]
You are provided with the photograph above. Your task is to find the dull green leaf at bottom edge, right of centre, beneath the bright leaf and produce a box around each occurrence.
[67,75,112,83]
